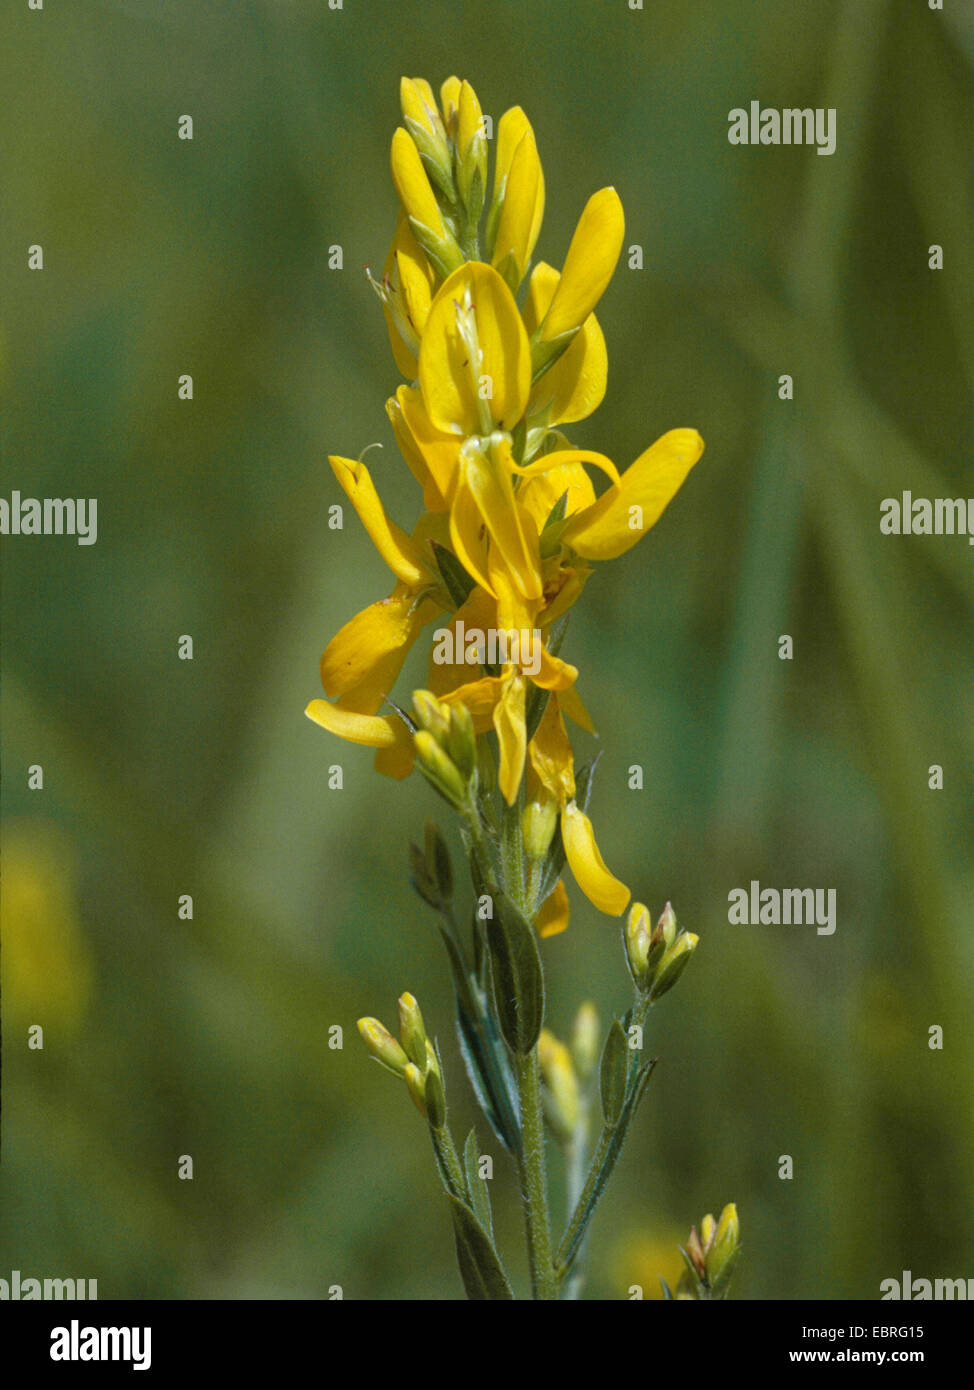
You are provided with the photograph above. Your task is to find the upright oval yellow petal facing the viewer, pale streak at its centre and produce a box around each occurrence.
[420,261,531,438]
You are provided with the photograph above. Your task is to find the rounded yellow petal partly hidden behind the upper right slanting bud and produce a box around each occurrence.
[524,261,609,425]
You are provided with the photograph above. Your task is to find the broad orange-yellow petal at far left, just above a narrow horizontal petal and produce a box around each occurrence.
[321,585,432,714]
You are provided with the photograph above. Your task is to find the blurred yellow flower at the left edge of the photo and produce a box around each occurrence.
[0,820,93,1045]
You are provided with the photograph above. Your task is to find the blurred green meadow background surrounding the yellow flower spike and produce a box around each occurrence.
[0,0,974,1298]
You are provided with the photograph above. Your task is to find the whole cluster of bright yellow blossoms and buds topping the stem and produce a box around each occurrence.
[307,78,703,933]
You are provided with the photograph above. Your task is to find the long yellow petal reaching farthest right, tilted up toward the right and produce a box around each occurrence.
[561,430,703,560]
